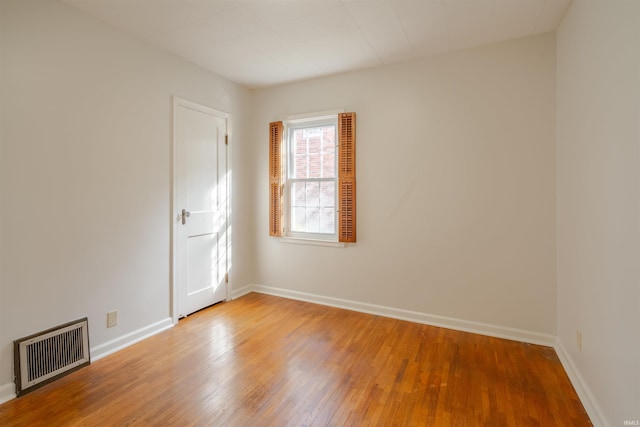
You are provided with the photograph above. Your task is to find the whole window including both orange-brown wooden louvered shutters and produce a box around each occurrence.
[269,113,356,242]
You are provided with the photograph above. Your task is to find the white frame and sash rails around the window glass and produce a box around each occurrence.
[282,110,344,246]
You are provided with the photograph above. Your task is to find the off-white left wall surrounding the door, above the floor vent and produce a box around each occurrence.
[0,0,253,398]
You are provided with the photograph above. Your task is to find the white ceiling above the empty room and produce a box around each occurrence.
[61,0,571,88]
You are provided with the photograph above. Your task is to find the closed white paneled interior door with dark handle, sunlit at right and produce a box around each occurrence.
[173,99,229,318]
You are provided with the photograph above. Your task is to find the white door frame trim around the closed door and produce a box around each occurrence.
[169,96,233,325]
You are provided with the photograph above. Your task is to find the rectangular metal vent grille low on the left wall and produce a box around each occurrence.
[13,317,91,396]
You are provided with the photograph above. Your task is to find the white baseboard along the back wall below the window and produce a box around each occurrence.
[245,285,556,347]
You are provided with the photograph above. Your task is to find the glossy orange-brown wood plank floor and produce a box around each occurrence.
[0,293,591,427]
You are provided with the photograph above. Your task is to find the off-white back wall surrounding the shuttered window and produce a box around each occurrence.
[253,34,556,336]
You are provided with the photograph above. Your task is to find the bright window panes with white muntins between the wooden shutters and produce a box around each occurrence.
[285,116,338,241]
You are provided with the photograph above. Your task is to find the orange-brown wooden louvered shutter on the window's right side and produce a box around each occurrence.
[338,113,356,242]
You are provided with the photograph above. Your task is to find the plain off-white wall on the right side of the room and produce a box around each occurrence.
[557,0,640,426]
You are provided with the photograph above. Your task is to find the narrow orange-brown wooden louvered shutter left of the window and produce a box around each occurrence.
[269,122,284,236]
